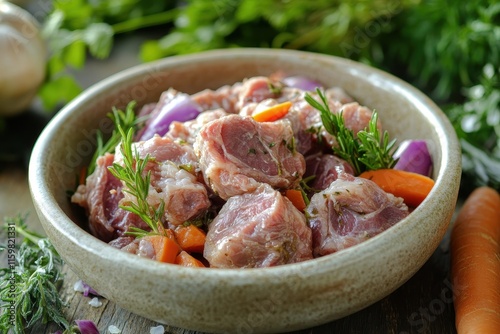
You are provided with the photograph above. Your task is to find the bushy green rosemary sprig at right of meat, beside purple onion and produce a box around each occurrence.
[305,89,396,175]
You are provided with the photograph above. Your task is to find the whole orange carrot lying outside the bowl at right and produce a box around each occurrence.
[450,187,500,334]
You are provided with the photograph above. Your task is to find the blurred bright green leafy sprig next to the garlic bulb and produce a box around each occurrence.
[39,0,178,110]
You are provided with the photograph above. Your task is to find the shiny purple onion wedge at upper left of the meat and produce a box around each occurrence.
[137,93,203,141]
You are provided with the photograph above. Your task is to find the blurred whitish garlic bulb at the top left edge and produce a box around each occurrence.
[0,1,46,116]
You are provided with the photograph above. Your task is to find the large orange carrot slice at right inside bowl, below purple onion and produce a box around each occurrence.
[359,169,434,208]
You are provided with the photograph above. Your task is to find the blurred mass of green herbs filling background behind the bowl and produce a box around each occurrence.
[0,0,500,193]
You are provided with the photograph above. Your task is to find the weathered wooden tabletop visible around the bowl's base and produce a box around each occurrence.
[0,163,456,334]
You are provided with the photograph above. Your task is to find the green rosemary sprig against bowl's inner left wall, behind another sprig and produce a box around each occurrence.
[87,101,142,175]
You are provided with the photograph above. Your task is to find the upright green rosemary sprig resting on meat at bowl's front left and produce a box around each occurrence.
[109,124,165,237]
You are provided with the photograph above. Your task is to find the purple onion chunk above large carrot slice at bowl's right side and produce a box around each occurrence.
[394,140,432,176]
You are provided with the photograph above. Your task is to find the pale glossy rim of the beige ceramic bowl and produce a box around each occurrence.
[28,48,460,281]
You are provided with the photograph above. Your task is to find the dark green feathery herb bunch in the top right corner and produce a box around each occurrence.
[371,0,500,103]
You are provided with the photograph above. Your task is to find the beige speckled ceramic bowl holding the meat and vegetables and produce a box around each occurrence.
[29,49,461,333]
